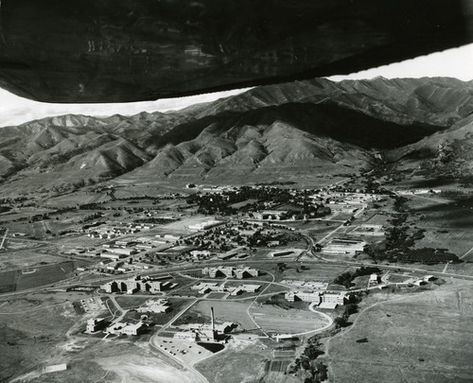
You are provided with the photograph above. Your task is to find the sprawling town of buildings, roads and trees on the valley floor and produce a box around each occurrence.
[1,179,464,383]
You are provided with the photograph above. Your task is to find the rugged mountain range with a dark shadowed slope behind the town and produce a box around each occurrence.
[0,78,473,194]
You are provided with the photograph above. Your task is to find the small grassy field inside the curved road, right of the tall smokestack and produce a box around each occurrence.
[250,304,329,334]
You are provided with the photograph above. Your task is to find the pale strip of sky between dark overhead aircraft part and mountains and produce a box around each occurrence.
[0,44,473,127]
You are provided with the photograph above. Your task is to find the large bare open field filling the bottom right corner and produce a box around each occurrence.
[328,282,473,383]
